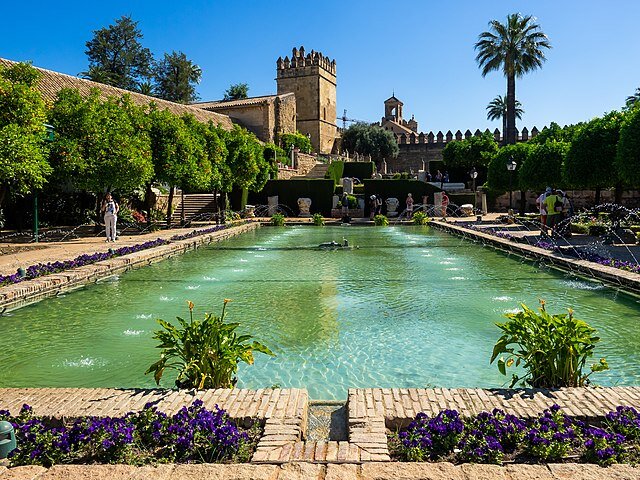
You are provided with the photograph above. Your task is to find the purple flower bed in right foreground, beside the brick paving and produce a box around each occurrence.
[389,405,640,466]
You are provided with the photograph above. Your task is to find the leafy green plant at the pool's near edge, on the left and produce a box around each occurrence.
[145,299,274,389]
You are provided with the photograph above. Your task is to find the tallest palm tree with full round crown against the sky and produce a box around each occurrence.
[475,13,551,144]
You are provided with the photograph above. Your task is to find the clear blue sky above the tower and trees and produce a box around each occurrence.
[0,0,640,132]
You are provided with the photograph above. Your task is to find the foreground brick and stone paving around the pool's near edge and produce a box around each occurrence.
[0,387,640,480]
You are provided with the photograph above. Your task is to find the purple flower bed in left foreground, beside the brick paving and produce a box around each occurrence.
[0,400,260,467]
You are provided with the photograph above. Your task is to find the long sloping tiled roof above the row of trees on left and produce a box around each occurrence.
[0,58,233,130]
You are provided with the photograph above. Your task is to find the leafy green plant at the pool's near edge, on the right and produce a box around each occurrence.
[491,301,609,388]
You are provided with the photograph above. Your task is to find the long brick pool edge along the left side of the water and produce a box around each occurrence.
[0,222,261,313]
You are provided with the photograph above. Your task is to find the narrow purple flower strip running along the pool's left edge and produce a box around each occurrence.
[0,238,169,287]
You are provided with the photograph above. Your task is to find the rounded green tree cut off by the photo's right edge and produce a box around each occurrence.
[615,103,640,187]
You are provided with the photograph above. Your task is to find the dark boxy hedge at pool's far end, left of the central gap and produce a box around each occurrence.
[249,178,334,217]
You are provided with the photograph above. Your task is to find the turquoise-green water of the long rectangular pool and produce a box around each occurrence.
[0,227,640,399]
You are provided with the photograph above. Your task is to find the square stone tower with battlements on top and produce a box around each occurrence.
[276,47,337,153]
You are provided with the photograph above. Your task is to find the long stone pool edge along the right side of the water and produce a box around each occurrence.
[429,220,640,295]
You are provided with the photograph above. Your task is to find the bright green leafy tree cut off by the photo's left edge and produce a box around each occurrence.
[0,63,51,205]
